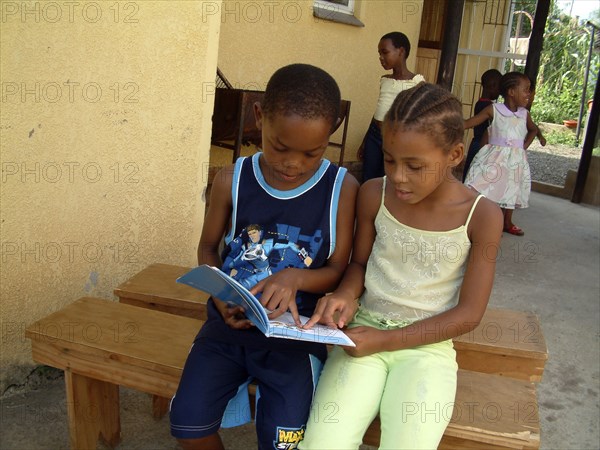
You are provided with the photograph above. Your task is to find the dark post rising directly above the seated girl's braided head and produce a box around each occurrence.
[437,0,465,91]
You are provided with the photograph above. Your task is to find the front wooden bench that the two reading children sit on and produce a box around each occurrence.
[26,297,539,449]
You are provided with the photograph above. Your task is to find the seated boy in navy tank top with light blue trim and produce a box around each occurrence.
[171,64,358,450]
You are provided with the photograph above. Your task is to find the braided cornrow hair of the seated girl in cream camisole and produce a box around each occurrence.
[384,82,465,151]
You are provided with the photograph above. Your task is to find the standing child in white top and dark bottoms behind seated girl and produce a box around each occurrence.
[358,31,425,181]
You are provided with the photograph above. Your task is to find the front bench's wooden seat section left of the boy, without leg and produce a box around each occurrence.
[25,297,203,398]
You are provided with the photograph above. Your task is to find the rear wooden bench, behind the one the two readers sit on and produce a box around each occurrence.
[114,264,548,382]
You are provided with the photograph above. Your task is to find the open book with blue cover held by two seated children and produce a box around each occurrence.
[177,264,355,347]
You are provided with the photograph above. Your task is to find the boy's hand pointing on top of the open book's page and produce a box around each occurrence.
[250,269,302,326]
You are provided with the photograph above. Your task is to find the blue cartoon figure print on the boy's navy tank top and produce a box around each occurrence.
[222,224,322,289]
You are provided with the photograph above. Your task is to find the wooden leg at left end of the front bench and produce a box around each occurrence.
[65,369,121,450]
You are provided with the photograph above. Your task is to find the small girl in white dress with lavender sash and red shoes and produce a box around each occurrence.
[465,72,538,236]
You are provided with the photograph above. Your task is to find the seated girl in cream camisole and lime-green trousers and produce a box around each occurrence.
[300,83,502,449]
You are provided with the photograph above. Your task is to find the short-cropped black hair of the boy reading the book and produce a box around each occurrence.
[261,64,341,129]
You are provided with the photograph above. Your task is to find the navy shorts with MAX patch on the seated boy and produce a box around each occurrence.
[171,337,322,449]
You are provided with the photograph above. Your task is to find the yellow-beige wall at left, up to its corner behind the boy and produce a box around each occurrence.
[0,0,221,390]
